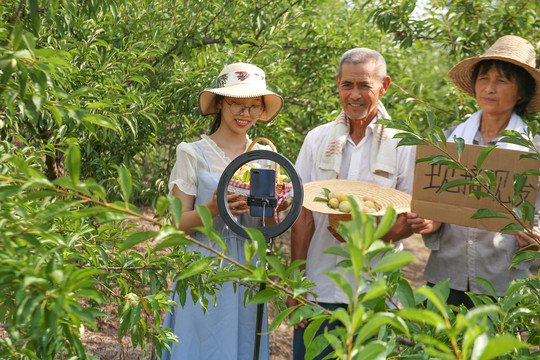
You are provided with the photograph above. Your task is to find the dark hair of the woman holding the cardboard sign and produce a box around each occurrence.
[471,59,536,116]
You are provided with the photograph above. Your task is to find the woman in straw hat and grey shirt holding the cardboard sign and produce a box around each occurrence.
[408,35,540,308]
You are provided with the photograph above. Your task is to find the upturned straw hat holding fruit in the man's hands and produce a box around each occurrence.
[303,179,411,227]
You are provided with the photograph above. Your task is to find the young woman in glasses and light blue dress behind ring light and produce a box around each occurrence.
[162,63,283,360]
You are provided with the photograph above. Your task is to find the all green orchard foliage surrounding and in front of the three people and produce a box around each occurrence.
[0,0,540,359]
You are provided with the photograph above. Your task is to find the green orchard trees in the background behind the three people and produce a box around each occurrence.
[0,0,539,204]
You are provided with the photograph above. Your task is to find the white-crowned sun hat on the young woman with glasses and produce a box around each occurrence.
[199,63,283,123]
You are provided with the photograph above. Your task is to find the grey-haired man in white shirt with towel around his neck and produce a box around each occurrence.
[287,48,414,359]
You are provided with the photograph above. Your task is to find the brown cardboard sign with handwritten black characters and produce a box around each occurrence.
[411,142,539,231]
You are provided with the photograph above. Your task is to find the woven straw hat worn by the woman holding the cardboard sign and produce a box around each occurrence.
[448,35,540,112]
